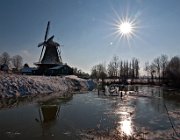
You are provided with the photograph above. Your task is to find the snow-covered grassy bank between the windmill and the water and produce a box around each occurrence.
[0,73,94,98]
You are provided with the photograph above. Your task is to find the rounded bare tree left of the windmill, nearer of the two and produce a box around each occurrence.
[11,55,23,70]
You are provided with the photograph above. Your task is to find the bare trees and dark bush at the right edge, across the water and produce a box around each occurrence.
[144,54,180,87]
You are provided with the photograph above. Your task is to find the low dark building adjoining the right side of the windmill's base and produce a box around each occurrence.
[46,64,73,76]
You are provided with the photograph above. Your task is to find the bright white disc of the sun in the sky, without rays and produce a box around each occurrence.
[119,22,133,35]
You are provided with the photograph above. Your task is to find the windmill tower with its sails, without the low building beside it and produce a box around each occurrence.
[35,21,62,73]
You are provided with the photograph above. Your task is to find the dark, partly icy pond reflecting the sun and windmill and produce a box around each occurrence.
[0,86,180,140]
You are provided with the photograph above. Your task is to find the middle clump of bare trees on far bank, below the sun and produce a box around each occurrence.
[91,56,139,82]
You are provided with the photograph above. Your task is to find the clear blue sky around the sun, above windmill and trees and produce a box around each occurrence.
[0,0,180,72]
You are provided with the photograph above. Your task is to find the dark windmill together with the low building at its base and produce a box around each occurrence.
[33,22,73,76]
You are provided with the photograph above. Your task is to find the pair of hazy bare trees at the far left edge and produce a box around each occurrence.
[0,52,23,71]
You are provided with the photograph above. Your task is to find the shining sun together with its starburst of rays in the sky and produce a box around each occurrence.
[106,6,140,47]
